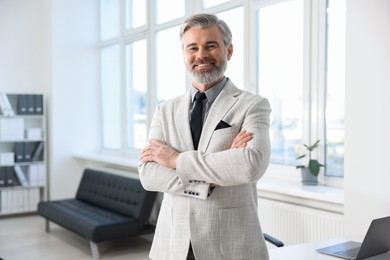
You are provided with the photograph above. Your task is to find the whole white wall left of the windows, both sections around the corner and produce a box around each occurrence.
[0,0,100,199]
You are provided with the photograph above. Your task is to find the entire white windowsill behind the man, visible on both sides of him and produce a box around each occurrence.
[74,152,344,214]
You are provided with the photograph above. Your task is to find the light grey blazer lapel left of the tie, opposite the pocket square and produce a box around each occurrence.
[174,91,194,151]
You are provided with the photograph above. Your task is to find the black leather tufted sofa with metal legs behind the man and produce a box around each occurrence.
[38,169,157,258]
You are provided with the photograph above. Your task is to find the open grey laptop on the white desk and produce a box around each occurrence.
[317,217,390,260]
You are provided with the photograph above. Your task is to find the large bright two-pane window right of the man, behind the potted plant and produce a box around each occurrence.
[255,0,345,177]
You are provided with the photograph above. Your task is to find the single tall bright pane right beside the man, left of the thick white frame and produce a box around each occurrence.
[256,0,304,165]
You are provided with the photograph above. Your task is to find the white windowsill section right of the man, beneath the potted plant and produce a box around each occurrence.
[257,176,344,214]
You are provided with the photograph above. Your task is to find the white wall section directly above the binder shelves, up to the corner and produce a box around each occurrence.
[0,0,48,94]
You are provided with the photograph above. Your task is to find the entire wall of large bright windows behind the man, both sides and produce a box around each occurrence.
[100,0,345,177]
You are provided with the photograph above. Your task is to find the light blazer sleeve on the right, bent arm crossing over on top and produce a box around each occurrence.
[176,97,271,186]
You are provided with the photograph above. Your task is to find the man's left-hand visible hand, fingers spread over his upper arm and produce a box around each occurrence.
[140,139,179,169]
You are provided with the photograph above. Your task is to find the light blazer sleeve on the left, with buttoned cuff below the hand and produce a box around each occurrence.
[138,104,210,199]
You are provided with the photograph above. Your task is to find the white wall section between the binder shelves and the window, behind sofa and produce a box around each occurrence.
[50,0,100,199]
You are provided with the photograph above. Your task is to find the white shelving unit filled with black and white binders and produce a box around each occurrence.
[0,93,48,216]
